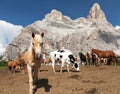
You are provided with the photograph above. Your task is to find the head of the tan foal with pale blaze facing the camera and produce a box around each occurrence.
[32,32,44,59]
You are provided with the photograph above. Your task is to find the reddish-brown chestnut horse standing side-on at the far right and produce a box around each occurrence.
[91,49,118,65]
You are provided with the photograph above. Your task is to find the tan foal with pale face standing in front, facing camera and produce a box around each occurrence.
[24,32,44,94]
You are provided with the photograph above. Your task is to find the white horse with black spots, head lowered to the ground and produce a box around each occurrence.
[50,49,79,73]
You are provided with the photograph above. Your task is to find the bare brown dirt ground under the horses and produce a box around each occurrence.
[0,66,120,94]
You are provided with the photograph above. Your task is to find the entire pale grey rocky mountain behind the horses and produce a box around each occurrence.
[4,3,120,59]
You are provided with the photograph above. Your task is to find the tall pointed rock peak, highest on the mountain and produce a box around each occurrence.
[87,3,107,22]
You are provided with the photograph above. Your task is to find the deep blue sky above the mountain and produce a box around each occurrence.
[0,0,120,26]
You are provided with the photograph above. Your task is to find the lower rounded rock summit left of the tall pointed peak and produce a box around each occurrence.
[45,9,63,20]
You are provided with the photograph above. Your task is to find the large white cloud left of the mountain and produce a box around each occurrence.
[0,20,23,55]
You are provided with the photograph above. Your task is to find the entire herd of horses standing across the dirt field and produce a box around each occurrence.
[8,32,117,94]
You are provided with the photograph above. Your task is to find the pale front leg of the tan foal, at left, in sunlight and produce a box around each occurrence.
[27,64,34,94]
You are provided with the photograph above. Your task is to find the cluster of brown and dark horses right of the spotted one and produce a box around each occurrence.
[79,49,118,65]
